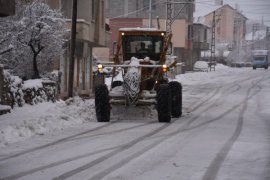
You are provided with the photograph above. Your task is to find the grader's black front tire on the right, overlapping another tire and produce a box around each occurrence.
[157,84,171,122]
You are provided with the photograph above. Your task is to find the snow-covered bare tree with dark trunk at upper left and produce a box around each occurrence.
[2,0,67,79]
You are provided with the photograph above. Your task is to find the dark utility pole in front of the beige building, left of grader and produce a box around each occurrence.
[68,0,77,98]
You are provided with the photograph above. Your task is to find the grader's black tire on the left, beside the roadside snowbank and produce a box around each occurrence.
[95,84,110,122]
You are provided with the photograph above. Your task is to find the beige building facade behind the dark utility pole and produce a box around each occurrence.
[48,0,108,97]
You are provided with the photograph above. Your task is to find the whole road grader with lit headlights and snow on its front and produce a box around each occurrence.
[95,28,182,122]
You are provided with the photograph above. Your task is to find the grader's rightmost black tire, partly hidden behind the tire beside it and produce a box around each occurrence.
[169,81,182,118]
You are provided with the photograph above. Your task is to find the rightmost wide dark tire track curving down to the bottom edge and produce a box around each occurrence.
[202,77,264,180]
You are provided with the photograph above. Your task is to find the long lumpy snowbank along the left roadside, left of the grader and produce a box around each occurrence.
[0,98,95,147]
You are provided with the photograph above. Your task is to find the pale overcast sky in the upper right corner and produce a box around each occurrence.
[223,0,270,26]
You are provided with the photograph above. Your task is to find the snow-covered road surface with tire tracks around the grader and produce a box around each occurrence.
[0,65,270,180]
